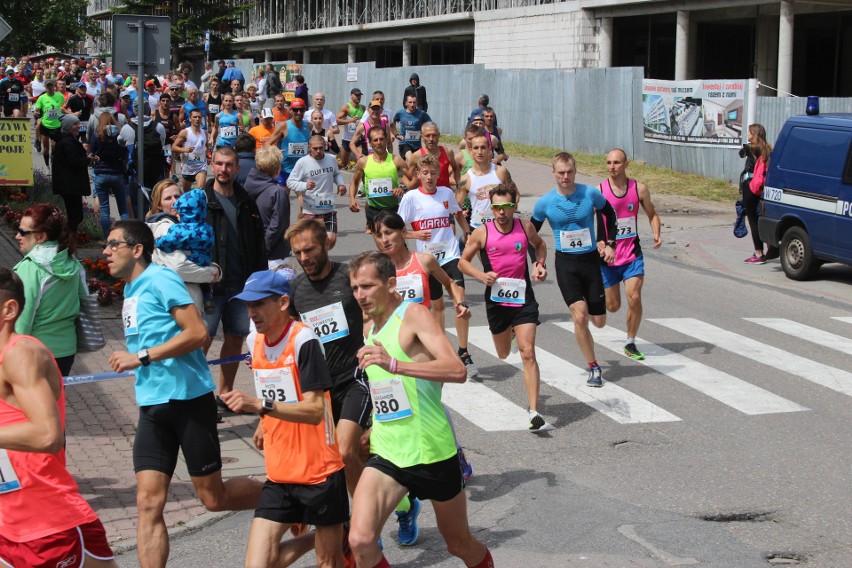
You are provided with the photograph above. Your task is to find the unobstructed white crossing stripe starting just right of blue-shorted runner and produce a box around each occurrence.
[649,318,852,396]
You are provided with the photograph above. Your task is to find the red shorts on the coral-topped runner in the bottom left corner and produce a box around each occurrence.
[0,519,113,568]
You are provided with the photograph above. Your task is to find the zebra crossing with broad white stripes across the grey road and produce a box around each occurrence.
[444,317,852,432]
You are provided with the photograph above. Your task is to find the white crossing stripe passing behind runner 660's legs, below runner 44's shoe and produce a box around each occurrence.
[456,326,680,424]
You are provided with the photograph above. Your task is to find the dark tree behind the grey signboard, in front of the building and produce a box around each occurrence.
[112,0,254,61]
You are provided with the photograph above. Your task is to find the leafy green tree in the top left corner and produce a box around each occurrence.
[0,0,101,56]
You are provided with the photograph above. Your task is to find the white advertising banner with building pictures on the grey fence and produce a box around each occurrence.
[642,79,747,147]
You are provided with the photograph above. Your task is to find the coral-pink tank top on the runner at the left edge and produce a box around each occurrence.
[0,335,98,542]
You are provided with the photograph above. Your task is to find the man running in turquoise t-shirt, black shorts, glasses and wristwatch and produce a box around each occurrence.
[104,221,263,568]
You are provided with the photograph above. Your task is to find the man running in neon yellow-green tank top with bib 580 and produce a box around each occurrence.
[349,252,494,568]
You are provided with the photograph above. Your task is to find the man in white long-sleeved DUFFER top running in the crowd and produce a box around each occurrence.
[287,135,346,250]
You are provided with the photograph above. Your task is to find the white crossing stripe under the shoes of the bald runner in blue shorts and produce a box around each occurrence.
[556,322,809,415]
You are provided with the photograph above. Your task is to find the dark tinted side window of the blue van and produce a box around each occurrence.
[778,126,852,178]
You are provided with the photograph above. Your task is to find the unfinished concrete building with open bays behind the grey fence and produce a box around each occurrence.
[89,0,852,96]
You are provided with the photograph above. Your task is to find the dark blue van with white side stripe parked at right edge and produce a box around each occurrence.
[758,114,852,280]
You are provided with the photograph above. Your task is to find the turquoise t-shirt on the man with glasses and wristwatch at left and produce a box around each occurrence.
[121,264,214,406]
